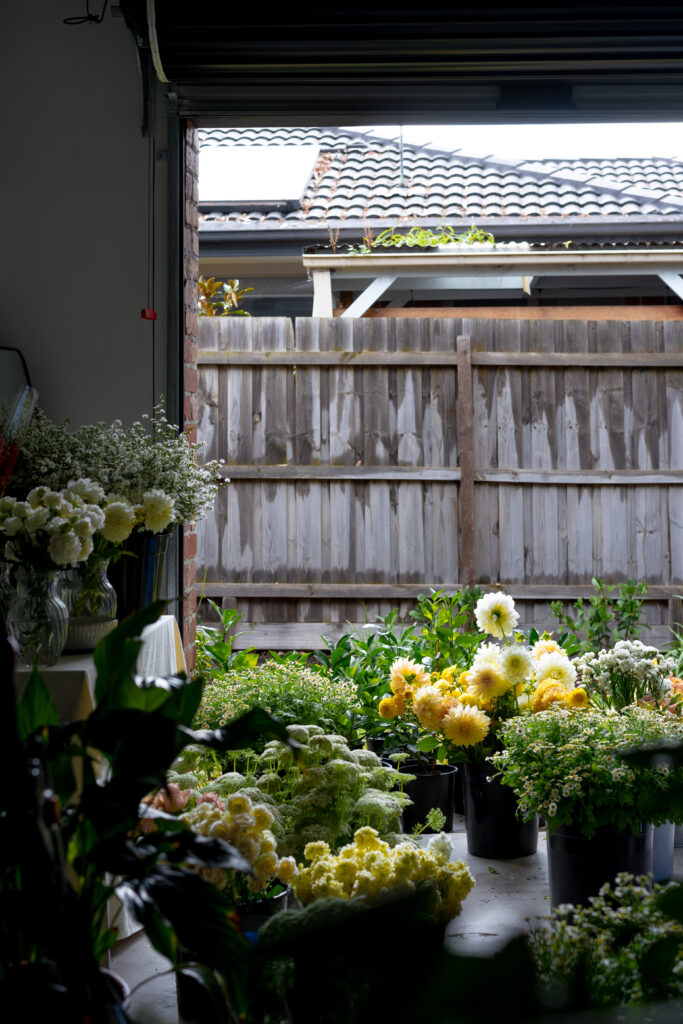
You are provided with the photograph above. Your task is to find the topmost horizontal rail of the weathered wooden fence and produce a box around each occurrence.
[198,350,683,370]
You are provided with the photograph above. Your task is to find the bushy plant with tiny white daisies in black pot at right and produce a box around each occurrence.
[490,706,683,906]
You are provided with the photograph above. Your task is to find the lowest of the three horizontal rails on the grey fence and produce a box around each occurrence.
[198,585,680,601]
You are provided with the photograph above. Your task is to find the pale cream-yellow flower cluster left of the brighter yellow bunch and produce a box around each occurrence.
[182,793,297,892]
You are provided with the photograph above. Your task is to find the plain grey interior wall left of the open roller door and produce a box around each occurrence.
[0,0,168,425]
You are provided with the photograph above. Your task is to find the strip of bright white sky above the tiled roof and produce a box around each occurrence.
[353,122,683,160]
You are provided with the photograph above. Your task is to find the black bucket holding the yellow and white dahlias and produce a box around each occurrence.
[462,761,539,860]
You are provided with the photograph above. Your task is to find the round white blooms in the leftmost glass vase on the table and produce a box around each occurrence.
[0,486,104,569]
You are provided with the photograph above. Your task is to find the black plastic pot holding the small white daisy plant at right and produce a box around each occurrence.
[548,822,652,906]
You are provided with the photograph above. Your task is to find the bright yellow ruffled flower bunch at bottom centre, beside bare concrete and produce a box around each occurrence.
[292,825,474,923]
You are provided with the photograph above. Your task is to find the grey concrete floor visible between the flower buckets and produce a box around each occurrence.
[111,815,683,1024]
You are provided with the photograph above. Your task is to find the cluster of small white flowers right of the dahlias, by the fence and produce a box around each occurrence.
[574,640,675,710]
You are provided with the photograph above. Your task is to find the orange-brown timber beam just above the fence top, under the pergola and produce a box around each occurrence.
[360,305,683,321]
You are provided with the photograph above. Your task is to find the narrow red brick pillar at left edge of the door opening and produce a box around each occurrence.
[182,121,200,674]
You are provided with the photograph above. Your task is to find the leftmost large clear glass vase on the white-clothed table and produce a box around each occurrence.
[6,566,69,668]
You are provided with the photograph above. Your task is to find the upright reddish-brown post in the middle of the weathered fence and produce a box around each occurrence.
[457,335,476,587]
